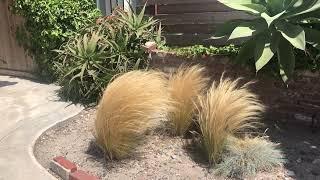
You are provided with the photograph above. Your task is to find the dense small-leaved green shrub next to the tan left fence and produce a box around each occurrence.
[12,0,100,78]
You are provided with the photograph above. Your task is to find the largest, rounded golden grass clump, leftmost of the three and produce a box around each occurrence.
[95,71,170,159]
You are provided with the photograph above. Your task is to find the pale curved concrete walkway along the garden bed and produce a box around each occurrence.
[0,76,82,180]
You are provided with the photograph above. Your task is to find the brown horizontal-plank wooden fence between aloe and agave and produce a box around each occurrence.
[138,0,250,45]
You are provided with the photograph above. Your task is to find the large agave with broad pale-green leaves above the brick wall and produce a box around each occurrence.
[214,0,320,82]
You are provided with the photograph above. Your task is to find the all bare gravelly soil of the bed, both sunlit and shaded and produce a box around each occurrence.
[34,109,320,180]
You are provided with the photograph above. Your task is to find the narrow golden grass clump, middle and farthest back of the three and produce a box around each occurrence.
[168,65,209,135]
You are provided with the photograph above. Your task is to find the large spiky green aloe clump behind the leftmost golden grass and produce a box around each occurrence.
[55,8,162,103]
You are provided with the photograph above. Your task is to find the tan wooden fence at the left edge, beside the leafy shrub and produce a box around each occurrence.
[0,0,35,76]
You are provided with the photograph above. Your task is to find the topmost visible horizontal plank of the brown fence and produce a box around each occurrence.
[158,2,232,14]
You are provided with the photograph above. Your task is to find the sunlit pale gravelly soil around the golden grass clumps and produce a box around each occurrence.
[34,109,289,179]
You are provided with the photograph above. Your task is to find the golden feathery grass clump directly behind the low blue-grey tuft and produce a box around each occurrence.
[197,77,264,164]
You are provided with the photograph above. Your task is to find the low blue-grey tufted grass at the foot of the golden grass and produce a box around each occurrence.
[215,137,285,178]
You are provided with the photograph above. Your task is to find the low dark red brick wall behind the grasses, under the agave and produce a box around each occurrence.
[151,52,320,126]
